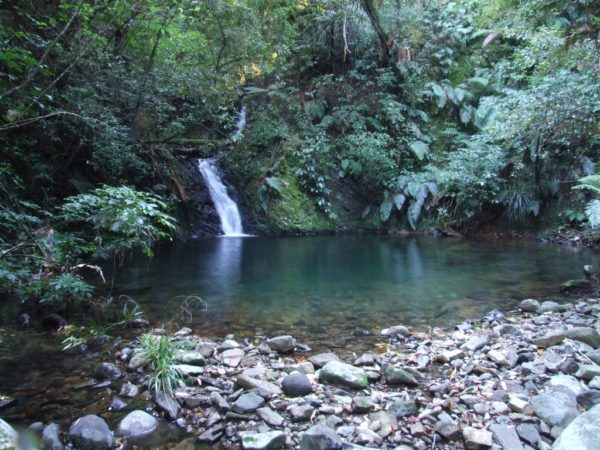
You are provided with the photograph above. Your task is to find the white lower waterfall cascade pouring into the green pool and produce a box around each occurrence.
[198,159,244,236]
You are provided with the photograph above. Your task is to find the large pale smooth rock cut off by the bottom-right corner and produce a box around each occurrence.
[552,405,600,450]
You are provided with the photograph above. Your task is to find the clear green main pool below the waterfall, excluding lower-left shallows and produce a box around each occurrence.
[117,236,600,347]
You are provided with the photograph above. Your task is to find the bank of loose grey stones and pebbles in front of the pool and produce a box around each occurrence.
[0,299,600,450]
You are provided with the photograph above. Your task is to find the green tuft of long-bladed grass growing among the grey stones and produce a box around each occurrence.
[139,334,182,397]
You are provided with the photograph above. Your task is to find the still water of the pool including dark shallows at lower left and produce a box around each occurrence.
[0,236,600,442]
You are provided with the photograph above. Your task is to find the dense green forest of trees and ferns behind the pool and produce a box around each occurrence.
[0,0,600,308]
